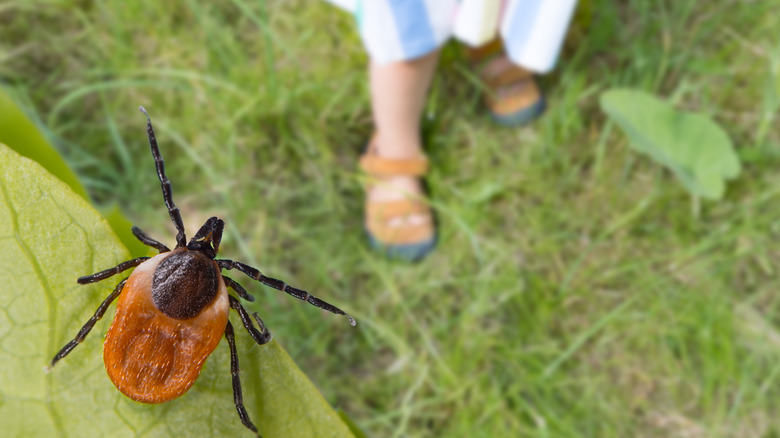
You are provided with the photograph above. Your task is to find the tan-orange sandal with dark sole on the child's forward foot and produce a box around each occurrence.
[360,135,436,261]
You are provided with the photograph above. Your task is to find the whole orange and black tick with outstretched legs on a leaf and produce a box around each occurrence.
[51,107,355,433]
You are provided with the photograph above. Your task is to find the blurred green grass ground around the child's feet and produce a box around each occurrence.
[0,0,780,437]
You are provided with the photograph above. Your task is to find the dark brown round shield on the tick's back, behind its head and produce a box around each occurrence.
[152,249,219,319]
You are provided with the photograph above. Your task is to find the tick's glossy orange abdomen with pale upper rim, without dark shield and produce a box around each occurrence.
[103,248,230,403]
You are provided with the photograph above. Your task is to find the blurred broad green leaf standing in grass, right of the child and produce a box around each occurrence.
[601,89,740,199]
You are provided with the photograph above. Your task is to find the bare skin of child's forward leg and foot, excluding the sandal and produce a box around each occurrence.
[368,51,439,225]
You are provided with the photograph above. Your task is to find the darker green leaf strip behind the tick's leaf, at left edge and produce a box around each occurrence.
[0,87,147,257]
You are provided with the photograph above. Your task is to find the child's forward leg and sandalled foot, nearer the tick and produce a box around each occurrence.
[361,52,438,261]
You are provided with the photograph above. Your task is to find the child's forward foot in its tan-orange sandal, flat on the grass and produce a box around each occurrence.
[360,136,436,261]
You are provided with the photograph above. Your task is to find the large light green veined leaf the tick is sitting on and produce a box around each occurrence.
[0,144,353,438]
